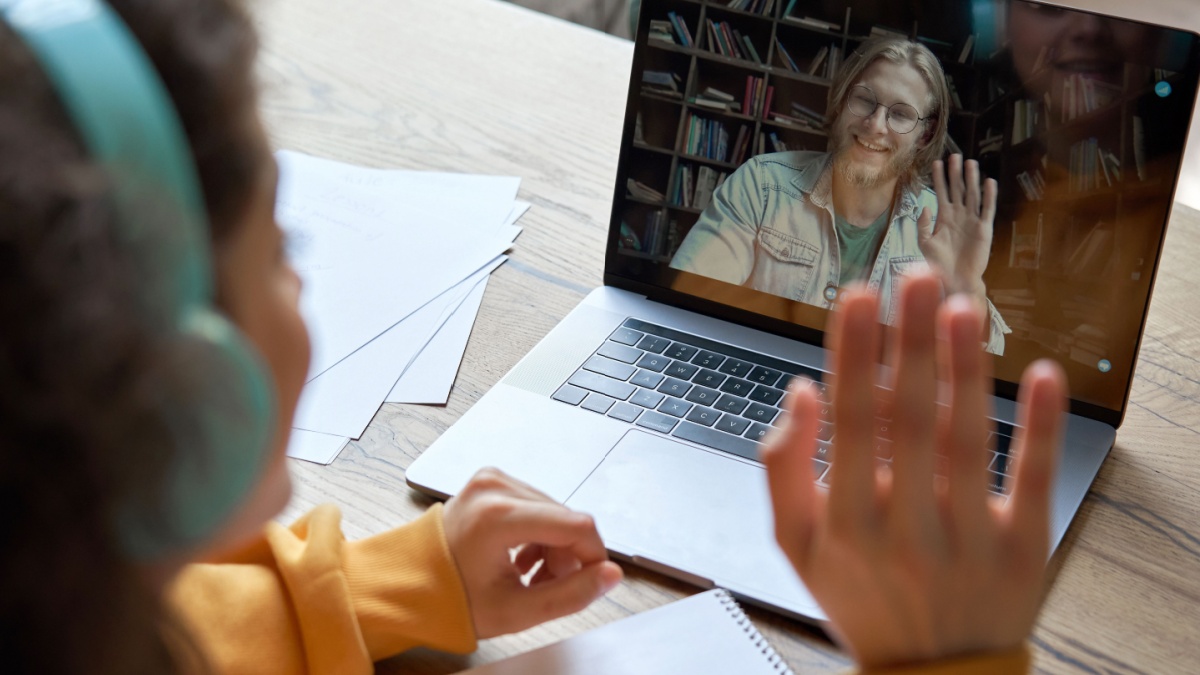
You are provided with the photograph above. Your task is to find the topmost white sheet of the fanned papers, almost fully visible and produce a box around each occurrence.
[276,151,520,378]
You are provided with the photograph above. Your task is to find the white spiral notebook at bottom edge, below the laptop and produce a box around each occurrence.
[460,589,792,675]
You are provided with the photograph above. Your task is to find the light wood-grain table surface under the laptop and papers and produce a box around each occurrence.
[258,0,1200,673]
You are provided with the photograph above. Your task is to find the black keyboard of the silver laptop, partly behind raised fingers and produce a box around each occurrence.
[553,318,1013,496]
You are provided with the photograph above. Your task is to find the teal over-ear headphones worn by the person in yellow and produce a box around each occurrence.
[0,0,275,561]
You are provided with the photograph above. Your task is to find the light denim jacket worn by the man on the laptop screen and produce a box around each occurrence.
[671,153,1012,354]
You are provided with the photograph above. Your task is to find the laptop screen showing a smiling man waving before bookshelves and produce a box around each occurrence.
[606,0,1200,411]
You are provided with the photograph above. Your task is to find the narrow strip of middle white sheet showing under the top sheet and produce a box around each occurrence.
[292,257,505,438]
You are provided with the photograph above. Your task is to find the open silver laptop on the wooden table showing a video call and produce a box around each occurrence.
[407,0,1200,621]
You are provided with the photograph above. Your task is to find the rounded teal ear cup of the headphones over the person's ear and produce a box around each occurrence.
[119,309,275,560]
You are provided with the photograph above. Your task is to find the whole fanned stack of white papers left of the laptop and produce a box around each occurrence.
[276,150,529,464]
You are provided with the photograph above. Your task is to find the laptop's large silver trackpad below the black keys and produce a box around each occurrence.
[566,430,823,619]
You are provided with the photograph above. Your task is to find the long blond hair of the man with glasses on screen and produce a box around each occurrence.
[826,38,950,186]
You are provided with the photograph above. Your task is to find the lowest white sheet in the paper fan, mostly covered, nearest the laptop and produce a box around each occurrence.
[388,202,529,405]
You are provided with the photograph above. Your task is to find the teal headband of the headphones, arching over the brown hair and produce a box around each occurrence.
[0,0,212,312]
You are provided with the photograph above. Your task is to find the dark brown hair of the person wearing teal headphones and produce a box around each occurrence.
[0,0,264,673]
